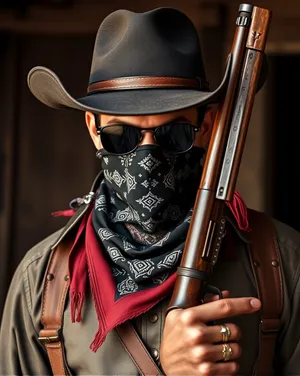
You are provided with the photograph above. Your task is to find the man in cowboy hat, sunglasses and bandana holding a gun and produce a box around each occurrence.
[0,8,300,375]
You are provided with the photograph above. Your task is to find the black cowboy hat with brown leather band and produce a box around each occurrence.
[28,8,230,115]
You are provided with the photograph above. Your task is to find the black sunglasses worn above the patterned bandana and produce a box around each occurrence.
[97,123,200,154]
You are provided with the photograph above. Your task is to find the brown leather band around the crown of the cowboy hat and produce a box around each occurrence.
[87,77,209,94]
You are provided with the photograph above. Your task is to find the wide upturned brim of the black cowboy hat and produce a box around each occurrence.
[28,55,231,115]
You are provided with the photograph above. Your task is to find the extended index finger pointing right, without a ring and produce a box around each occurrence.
[181,298,261,324]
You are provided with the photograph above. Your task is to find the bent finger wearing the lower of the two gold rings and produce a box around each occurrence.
[189,343,242,364]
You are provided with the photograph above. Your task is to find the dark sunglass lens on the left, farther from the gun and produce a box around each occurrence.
[101,124,140,154]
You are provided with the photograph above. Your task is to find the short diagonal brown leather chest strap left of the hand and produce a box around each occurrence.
[115,321,163,376]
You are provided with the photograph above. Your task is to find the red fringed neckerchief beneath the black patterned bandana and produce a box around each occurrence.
[54,192,250,351]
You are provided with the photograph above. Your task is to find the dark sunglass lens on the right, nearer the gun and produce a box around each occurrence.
[155,123,195,154]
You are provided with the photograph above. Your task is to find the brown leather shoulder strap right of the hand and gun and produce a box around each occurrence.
[248,210,283,376]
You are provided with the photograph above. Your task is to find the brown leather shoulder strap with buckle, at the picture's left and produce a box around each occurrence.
[39,240,72,375]
